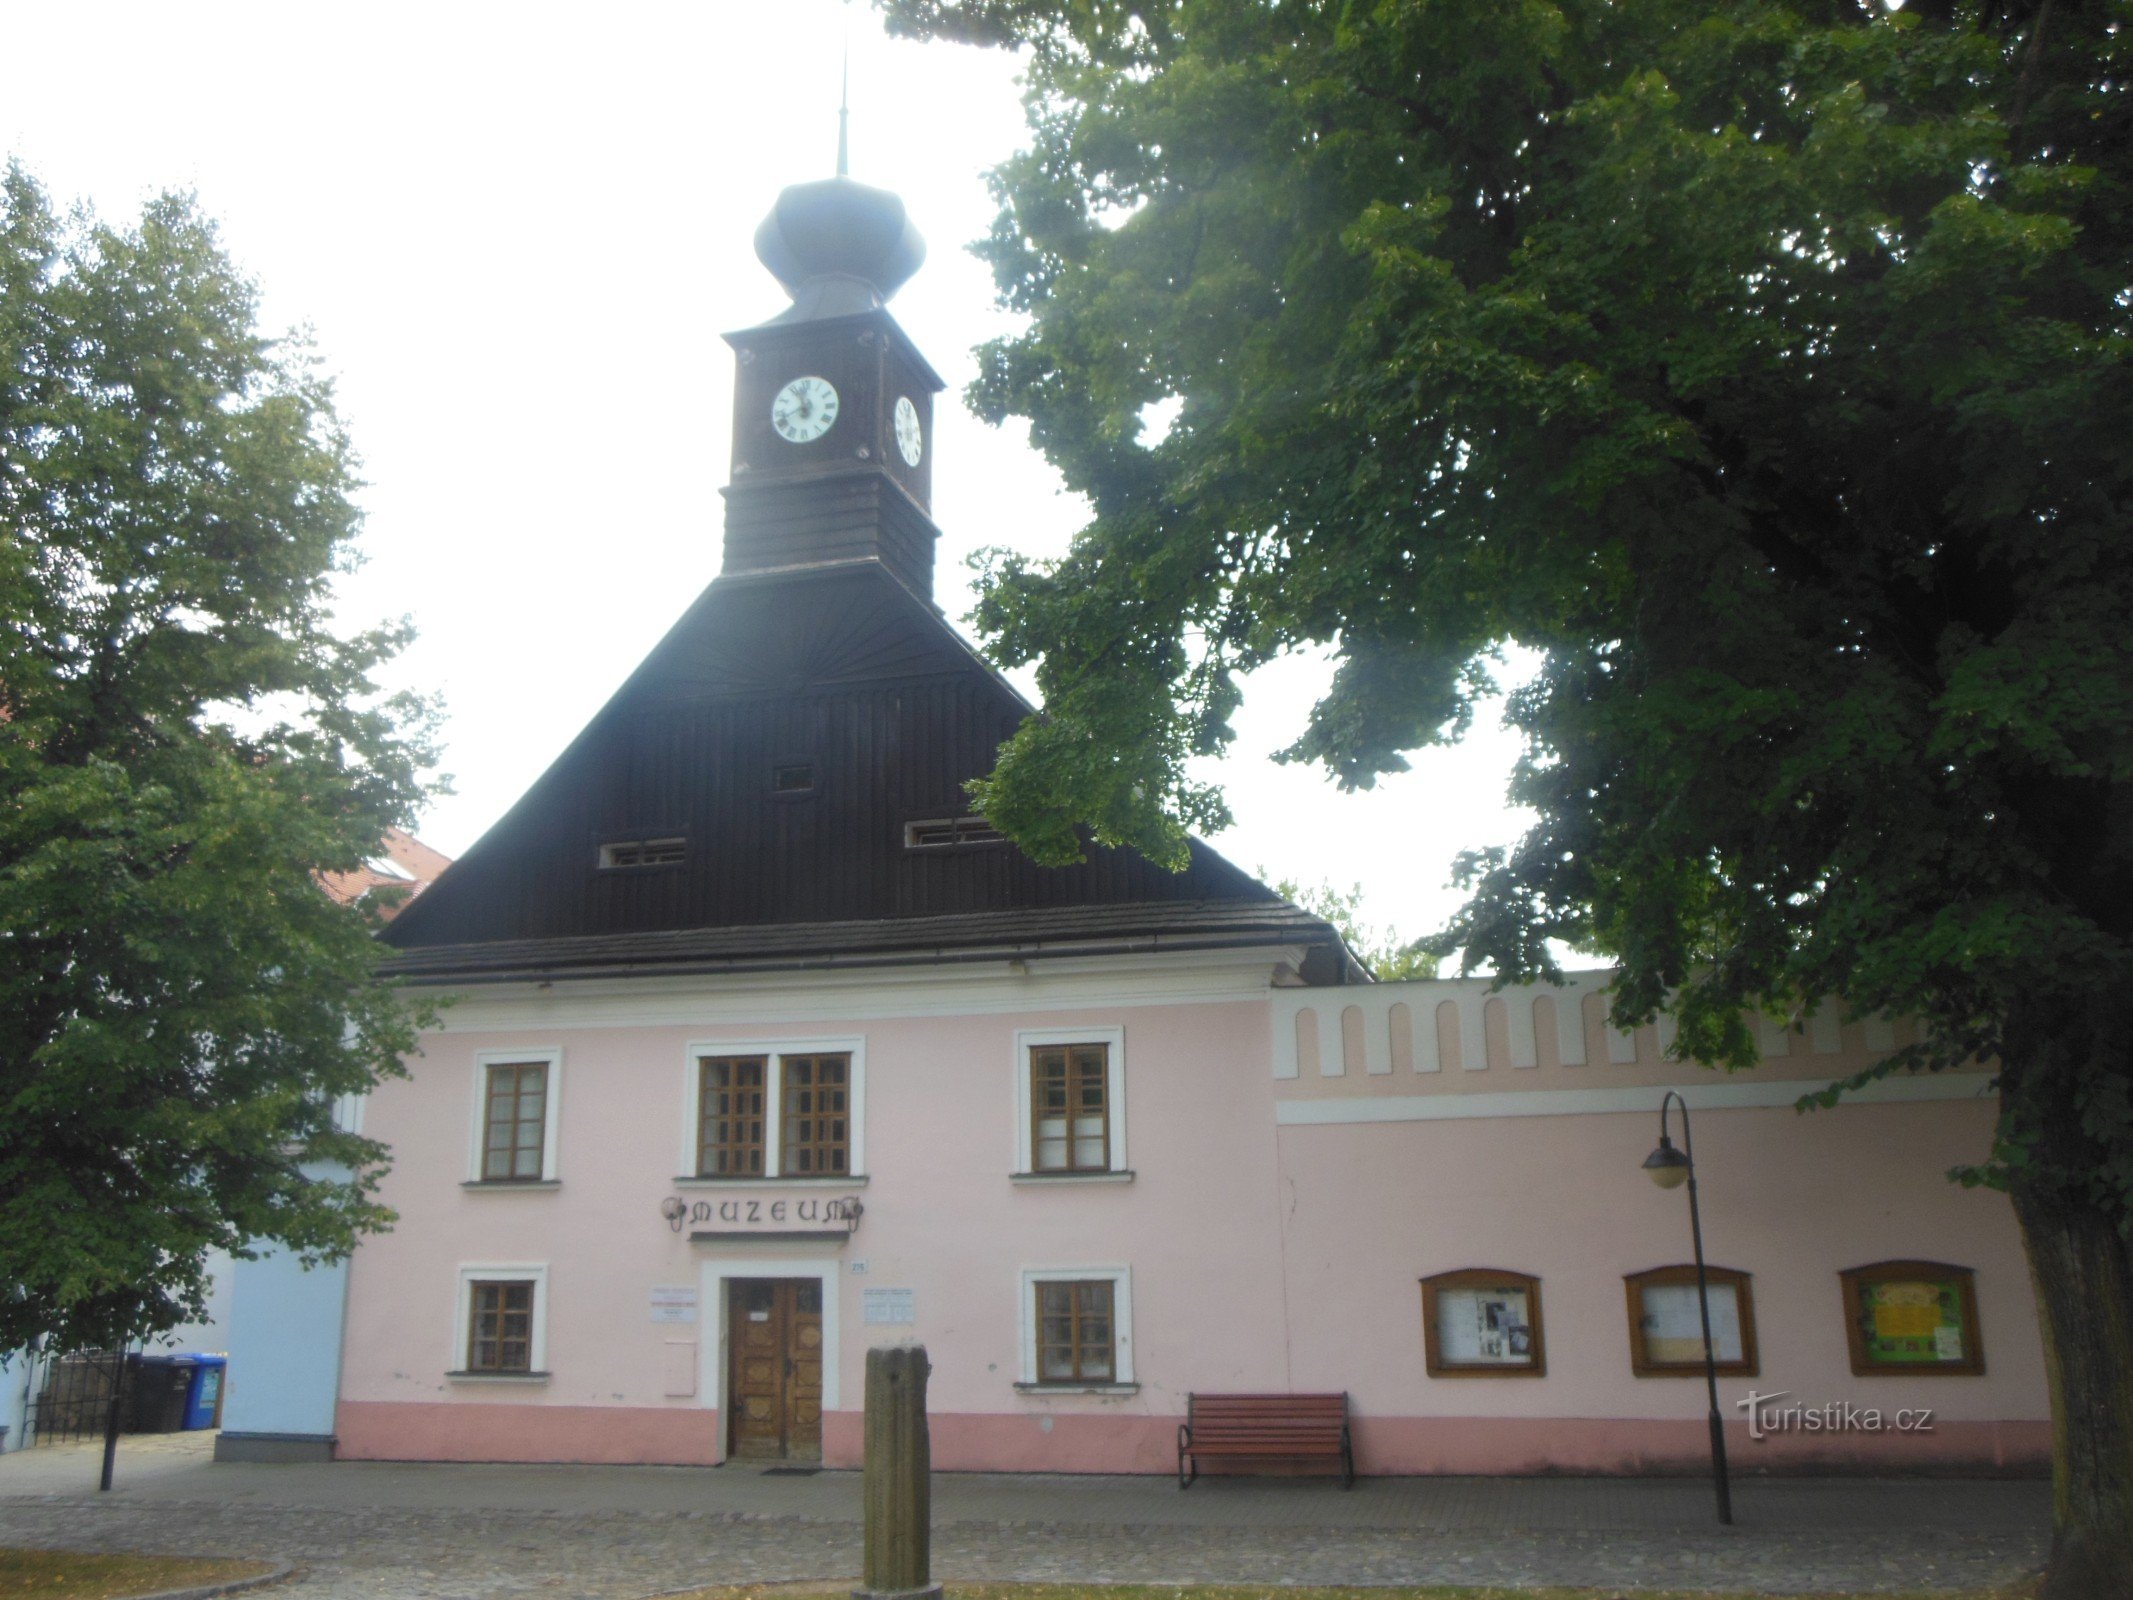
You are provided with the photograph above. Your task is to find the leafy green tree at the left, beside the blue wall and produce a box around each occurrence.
[0,166,431,1348]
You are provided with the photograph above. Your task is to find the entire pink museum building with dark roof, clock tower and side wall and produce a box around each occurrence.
[319,179,2048,1472]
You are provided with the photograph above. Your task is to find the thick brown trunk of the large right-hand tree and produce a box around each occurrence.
[2011,1180,2133,1600]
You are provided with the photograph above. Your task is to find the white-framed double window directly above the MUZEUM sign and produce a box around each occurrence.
[680,1039,866,1184]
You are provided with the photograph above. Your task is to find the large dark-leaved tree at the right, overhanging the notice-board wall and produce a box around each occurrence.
[883,0,2133,1600]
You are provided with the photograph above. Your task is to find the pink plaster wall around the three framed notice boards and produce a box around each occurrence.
[1280,1101,2048,1472]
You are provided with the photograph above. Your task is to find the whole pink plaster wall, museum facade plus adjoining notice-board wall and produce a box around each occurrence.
[339,972,2046,1472]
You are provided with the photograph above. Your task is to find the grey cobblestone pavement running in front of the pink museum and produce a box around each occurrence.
[0,1436,2048,1600]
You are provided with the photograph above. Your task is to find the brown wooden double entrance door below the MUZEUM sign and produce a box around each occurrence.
[725,1278,821,1461]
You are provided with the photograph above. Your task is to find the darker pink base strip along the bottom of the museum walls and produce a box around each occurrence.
[337,1399,2052,1476]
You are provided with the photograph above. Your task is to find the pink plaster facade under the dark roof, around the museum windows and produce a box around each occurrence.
[341,1001,1282,1470]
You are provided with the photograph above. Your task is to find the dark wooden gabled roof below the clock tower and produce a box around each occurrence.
[384,561,1361,981]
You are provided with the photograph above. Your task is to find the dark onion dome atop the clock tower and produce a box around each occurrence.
[755,177,926,322]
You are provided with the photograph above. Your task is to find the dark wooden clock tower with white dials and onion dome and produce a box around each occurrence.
[723,177,943,602]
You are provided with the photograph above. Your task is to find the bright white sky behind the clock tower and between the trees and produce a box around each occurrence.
[0,0,1527,951]
